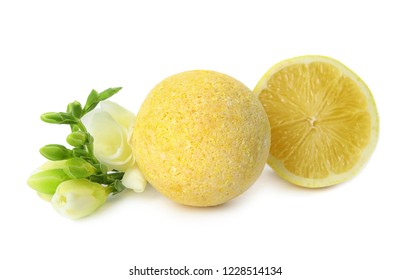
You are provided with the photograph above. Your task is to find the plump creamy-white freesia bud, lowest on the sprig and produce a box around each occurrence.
[51,179,110,219]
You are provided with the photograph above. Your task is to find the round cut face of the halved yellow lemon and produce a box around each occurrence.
[254,56,379,188]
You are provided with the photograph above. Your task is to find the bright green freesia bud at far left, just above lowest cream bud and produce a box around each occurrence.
[27,169,70,194]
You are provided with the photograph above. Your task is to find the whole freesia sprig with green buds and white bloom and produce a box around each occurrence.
[27,87,146,218]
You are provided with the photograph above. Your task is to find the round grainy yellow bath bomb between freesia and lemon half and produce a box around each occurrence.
[132,70,270,206]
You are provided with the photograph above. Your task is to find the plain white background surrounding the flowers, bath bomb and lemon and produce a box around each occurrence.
[0,0,411,280]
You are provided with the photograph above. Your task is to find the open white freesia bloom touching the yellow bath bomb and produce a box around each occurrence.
[82,100,134,171]
